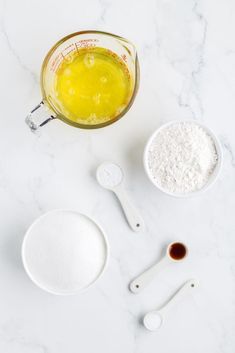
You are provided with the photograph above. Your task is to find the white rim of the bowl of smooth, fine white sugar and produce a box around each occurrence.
[21,209,109,296]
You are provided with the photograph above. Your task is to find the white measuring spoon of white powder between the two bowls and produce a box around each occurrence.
[96,162,144,232]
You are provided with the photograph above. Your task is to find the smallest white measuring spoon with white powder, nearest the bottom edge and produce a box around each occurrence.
[143,279,198,331]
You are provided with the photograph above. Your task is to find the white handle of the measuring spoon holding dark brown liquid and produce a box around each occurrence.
[130,256,170,294]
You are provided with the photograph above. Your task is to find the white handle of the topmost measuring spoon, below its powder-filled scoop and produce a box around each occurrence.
[113,187,144,232]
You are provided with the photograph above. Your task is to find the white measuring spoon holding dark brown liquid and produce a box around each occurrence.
[130,242,188,294]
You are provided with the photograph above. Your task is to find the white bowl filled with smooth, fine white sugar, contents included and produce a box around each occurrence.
[22,210,108,295]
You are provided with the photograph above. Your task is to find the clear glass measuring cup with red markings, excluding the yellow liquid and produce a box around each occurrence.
[26,31,139,131]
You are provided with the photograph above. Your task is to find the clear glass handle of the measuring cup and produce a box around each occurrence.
[25,101,56,132]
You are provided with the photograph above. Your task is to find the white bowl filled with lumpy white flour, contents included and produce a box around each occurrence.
[144,120,222,197]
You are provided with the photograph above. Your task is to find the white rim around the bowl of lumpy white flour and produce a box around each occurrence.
[143,120,223,198]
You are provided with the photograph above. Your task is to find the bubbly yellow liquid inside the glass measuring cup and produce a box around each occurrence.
[54,47,133,125]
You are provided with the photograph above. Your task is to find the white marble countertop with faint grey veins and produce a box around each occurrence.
[0,0,235,353]
